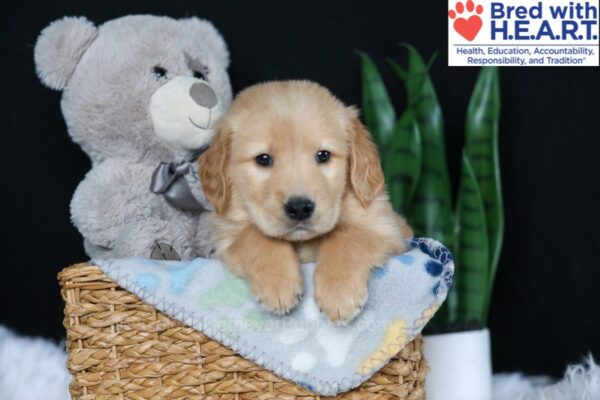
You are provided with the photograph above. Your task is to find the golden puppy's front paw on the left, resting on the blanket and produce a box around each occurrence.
[251,266,303,315]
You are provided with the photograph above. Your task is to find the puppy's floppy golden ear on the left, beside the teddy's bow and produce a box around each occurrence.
[198,124,232,214]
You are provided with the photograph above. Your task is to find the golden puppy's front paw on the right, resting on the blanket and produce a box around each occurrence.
[315,268,369,325]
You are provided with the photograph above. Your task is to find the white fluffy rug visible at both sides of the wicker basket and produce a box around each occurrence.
[0,326,600,400]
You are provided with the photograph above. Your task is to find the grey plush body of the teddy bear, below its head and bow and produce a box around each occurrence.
[71,160,197,259]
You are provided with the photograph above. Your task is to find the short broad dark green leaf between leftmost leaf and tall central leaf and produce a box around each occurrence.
[384,108,421,215]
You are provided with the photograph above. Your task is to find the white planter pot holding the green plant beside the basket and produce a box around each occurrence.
[424,329,492,400]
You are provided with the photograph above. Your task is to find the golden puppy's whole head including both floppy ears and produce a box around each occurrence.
[200,82,383,241]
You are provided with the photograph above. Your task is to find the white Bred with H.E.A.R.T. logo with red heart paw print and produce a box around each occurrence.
[448,0,599,66]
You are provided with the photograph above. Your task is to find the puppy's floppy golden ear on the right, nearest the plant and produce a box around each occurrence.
[348,108,385,208]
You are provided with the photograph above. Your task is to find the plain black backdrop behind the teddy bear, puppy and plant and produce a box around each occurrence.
[0,0,600,375]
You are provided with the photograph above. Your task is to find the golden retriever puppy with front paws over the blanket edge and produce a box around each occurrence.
[199,81,412,323]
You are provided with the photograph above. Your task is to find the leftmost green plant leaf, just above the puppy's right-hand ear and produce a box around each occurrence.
[356,51,396,150]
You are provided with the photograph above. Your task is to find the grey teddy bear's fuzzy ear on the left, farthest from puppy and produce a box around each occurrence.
[34,17,98,90]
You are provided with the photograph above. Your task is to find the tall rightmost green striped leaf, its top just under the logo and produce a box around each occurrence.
[465,67,504,322]
